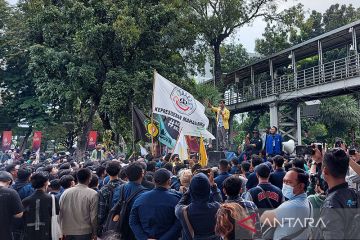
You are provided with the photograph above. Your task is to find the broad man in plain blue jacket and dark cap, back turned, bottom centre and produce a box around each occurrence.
[129,168,181,240]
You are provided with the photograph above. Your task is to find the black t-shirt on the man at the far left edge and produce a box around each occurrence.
[0,187,23,240]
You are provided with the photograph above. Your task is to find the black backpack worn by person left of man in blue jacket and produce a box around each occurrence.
[103,185,145,239]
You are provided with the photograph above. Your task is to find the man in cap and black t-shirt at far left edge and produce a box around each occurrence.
[0,171,23,240]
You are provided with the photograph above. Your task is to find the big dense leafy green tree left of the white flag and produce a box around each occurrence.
[21,0,194,157]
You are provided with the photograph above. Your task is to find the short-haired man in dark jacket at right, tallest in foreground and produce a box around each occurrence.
[313,148,360,239]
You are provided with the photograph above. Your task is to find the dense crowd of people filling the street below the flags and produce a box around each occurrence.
[0,137,360,240]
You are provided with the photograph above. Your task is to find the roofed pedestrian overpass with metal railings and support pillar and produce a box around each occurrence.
[224,21,360,144]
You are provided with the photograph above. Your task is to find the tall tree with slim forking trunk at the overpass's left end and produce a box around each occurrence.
[188,0,276,84]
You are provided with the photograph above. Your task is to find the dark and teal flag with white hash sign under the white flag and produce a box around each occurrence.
[156,114,180,149]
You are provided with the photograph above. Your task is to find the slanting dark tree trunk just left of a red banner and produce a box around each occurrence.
[75,104,97,162]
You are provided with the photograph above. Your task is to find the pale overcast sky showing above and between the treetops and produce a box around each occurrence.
[7,0,360,52]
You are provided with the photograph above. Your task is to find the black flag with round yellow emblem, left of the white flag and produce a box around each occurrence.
[132,106,159,142]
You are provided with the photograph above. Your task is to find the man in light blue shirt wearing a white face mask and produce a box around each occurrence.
[260,168,312,239]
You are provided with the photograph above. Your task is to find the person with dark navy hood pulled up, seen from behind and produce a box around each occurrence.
[175,173,221,240]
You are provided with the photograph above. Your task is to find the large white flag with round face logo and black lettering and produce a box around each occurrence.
[153,73,209,135]
